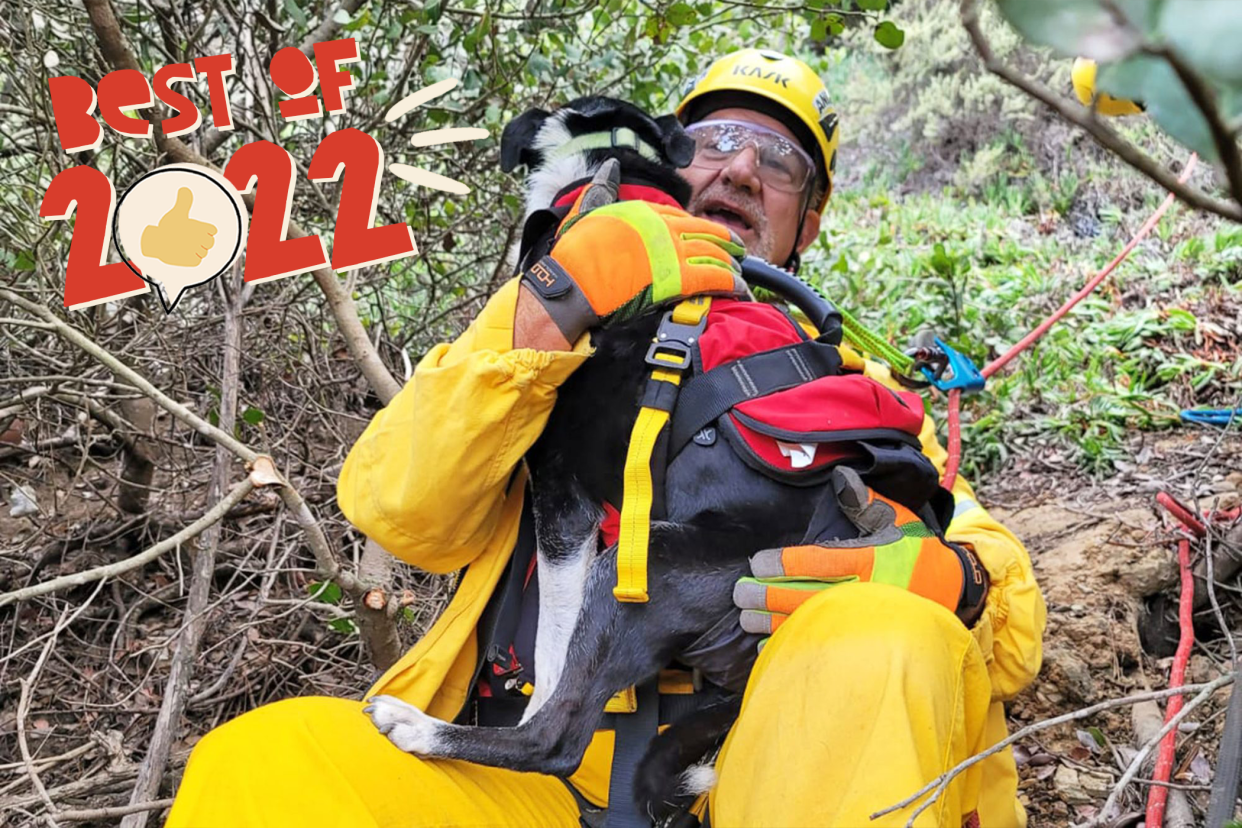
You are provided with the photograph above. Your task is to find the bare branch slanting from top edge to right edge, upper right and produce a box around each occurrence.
[960,0,1242,223]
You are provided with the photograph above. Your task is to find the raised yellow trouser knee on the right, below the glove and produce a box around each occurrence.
[709,583,1021,828]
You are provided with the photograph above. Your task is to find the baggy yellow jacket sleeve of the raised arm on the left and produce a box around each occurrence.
[337,278,591,572]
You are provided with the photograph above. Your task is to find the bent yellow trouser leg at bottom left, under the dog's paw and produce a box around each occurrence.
[166,696,579,828]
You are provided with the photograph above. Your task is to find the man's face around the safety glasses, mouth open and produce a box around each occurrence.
[681,108,820,264]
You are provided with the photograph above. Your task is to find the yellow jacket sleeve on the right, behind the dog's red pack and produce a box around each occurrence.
[842,348,1047,700]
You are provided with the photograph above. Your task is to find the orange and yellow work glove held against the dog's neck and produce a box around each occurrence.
[522,163,746,343]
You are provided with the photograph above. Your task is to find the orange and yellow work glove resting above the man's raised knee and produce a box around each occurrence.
[733,467,987,636]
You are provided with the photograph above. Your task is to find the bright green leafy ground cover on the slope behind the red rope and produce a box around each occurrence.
[809,186,1242,472]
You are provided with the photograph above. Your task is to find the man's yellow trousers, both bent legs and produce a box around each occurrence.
[168,583,1008,828]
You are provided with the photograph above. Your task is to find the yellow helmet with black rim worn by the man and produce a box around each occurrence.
[676,48,837,212]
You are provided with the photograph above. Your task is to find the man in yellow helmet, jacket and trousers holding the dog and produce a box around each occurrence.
[162,50,1045,828]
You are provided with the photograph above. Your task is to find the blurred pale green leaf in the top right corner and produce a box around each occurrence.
[1160,0,1242,86]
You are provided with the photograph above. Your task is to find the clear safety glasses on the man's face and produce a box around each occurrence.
[686,120,815,192]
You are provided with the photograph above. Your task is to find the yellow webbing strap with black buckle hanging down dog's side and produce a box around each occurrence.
[612,297,712,603]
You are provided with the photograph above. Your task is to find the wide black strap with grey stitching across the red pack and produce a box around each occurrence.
[668,340,841,458]
